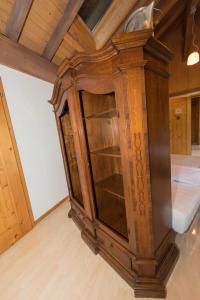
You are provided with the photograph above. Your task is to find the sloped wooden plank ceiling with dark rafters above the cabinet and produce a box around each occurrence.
[0,0,199,81]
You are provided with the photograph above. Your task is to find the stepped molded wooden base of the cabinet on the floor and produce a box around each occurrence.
[69,209,179,298]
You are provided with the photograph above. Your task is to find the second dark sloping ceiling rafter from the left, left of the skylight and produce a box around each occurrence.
[43,0,84,60]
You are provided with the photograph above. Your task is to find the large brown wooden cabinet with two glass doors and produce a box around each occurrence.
[51,30,178,298]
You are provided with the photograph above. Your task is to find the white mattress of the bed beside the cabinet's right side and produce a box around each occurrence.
[172,182,200,233]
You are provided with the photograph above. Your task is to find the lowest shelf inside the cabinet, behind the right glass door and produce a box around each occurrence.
[96,174,124,199]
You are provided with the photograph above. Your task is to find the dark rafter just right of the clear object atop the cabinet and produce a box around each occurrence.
[155,0,186,39]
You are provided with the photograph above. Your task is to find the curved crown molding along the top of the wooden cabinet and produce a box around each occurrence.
[49,29,173,111]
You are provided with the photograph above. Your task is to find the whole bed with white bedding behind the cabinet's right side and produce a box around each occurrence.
[172,164,200,234]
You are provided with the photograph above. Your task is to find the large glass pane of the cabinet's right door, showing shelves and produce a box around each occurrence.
[80,92,128,238]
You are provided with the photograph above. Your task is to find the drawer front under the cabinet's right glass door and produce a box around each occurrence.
[97,230,132,270]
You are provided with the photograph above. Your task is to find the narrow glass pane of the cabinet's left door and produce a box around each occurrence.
[60,107,83,206]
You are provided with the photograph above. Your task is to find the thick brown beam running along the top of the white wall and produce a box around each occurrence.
[0,34,57,83]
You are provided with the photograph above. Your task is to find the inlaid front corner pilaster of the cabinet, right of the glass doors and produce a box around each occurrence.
[123,66,155,268]
